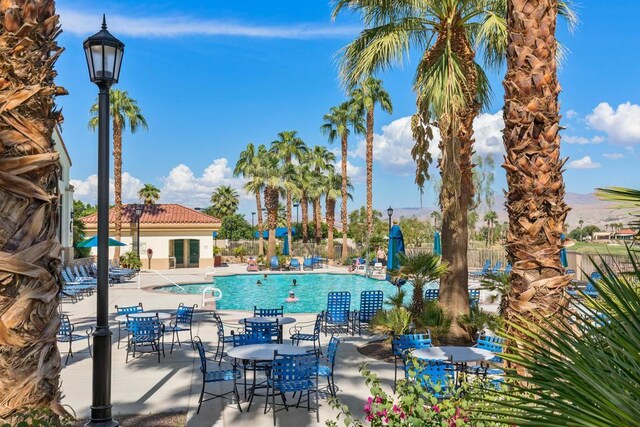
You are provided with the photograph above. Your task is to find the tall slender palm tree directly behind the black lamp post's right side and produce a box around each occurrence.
[89,89,148,260]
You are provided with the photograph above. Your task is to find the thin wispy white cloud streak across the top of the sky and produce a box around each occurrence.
[58,8,360,39]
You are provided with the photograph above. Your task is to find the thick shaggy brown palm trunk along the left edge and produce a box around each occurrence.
[0,0,67,418]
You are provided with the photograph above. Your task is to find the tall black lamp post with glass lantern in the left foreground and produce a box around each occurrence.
[83,15,124,427]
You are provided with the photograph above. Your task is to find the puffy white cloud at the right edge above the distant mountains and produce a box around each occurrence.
[586,102,640,145]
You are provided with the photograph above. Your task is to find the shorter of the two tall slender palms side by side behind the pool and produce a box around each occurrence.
[320,102,365,260]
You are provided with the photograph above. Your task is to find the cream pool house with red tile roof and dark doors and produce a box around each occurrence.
[82,204,221,270]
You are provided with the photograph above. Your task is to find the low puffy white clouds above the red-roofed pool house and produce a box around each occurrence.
[70,158,248,207]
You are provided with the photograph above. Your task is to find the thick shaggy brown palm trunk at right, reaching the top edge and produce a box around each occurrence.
[503,0,570,362]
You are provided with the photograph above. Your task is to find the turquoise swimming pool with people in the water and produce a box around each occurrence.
[157,273,420,313]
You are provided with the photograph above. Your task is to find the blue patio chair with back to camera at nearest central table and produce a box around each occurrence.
[264,351,320,426]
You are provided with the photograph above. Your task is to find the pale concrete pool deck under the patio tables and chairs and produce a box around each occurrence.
[62,265,393,427]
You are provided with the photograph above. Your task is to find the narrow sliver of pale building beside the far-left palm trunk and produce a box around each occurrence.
[52,125,73,263]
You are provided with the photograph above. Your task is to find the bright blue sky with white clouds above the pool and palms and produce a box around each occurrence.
[57,0,640,213]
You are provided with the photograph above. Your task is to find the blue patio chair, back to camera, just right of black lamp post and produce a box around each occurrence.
[125,314,164,363]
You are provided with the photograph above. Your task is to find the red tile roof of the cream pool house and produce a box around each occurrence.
[80,204,220,224]
